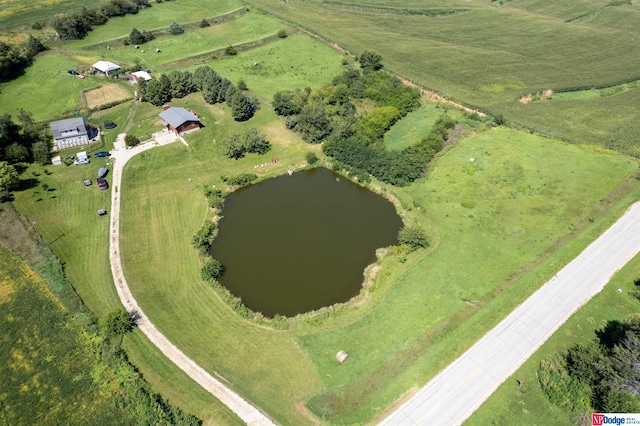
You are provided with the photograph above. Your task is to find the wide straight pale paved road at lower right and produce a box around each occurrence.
[381,203,640,426]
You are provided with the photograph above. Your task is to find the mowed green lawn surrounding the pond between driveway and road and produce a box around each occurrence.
[116,120,637,424]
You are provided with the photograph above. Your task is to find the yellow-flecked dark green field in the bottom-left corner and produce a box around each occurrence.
[0,241,122,424]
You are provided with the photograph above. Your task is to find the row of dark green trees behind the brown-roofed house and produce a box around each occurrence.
[138,66,257,121]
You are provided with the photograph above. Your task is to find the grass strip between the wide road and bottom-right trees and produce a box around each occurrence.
[465,256,640,426]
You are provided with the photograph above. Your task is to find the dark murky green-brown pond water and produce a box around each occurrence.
[211,168,402,317]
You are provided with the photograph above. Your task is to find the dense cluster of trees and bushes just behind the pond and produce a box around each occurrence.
[273,51,455,186]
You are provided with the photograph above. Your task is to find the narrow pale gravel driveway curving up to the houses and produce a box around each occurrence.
[109,134,274,426]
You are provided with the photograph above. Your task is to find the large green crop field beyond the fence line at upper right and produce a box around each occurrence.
[249,0,640,156]
